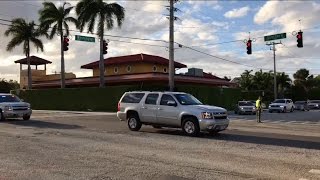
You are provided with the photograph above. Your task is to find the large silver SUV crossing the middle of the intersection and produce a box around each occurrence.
[117,91,229,136]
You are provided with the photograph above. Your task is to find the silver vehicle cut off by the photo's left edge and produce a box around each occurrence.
[0,94,32,120]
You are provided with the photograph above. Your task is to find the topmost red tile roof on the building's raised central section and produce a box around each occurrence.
[81,54,187,69]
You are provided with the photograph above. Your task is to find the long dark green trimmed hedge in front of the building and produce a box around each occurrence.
[12,85,241,112]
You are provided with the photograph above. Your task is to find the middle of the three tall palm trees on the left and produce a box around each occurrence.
[39,2,77,88]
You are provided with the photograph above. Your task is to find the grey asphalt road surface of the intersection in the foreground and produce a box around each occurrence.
[0,111,320,180]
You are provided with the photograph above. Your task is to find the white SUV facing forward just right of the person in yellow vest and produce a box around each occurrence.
[269,99,294,113]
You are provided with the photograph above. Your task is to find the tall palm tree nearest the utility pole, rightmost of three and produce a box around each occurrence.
[76,0,125,87]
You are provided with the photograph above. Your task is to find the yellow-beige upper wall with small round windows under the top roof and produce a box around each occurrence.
[93,63,169,76]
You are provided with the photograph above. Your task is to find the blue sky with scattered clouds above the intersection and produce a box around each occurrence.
[0,0,320,80]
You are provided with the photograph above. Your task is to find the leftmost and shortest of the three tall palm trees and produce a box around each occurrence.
[4,18,48,89]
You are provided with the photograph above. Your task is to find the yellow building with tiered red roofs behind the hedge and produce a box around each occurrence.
[15,54,236,89]
